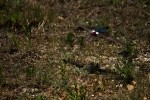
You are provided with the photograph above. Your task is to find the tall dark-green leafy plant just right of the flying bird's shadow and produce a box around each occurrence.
[116,42,135,84]
